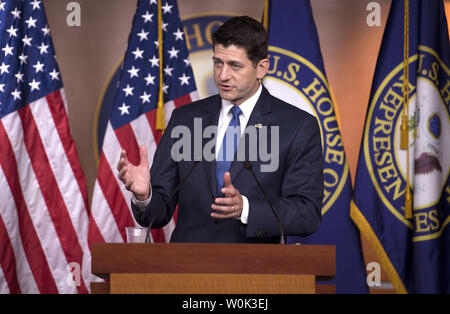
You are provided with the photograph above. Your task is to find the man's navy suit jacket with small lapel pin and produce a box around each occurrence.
[132,87,323,243]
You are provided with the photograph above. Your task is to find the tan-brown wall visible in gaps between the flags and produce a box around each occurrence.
[44,0,450,294]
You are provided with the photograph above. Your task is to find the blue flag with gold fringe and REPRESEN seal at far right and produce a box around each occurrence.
[352,0,450,293]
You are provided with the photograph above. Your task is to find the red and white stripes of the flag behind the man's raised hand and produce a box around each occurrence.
[89,91,198,243]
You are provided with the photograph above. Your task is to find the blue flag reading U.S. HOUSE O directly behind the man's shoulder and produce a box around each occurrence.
[264,0,367,293]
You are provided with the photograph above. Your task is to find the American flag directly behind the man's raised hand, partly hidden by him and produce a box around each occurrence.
[89,0,198,243]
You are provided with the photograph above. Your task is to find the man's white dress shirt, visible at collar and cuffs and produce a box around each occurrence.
[131,84,262,224]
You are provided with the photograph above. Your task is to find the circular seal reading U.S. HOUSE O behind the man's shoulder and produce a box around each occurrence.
[264,46,349,215]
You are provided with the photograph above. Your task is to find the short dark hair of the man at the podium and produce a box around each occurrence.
[212,16,268,66]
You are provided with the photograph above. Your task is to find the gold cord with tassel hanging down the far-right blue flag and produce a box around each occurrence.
[400,0,413,219]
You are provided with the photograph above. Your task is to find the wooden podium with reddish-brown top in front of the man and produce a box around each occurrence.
[91,243,336,294]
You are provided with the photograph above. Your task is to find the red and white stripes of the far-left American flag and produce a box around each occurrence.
[0,89,95,293]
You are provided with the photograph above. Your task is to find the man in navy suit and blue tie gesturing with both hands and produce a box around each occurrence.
[117,16,323,243]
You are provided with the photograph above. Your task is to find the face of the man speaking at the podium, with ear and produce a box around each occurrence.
[213,44,269,105]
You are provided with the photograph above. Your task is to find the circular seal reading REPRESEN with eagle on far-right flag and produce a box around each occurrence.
[363,46,450,241]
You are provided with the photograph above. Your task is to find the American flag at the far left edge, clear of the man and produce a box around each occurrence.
[0,0,91,293]
